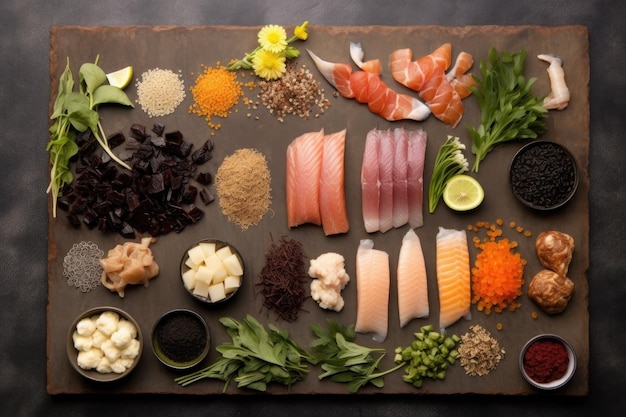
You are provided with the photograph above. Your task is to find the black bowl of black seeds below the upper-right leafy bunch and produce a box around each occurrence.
[509,140,578,210]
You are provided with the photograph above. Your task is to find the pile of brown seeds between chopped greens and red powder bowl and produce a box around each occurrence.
[458,324,505,376]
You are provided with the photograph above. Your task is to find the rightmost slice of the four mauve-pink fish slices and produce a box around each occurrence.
[397,129,427,228]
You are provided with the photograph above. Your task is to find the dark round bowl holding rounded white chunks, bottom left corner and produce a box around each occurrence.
[67,306,143,382]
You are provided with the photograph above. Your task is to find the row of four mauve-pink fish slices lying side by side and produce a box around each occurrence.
[361,128,427,233]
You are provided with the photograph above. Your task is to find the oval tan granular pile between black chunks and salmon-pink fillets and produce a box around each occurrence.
[215,148,272,230]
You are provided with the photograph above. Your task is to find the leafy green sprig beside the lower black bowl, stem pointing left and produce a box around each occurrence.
[174,315,316,392]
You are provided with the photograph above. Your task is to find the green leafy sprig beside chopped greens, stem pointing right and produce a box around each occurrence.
[310,320,404,393]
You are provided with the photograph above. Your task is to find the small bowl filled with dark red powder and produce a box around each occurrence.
[519,334,576,390]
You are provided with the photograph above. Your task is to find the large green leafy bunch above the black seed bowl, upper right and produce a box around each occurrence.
[468,48,548,172]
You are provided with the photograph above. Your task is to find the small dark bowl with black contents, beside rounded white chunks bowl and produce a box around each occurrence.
[152,309,211,370]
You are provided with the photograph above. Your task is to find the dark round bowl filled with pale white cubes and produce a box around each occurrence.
[180,239,245,305]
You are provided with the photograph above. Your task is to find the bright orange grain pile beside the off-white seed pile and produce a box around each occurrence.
[189,62,243,130]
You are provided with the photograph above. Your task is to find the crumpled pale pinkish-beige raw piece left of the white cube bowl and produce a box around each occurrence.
[100,237,159,298]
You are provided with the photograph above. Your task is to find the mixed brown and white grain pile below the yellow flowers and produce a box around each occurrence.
[258,62,330,122]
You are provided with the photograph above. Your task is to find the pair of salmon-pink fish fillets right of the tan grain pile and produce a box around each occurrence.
[285,129,349,236]
